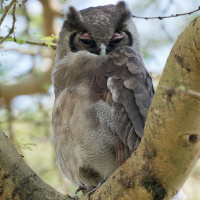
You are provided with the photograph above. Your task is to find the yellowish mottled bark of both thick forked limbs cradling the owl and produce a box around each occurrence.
[0,17,200,200]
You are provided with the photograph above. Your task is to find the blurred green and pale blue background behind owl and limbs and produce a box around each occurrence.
[0,0,200,200]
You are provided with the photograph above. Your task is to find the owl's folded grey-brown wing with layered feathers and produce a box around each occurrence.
[91,46,154,165]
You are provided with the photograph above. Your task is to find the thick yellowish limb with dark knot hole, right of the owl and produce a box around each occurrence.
[88,17,200,200]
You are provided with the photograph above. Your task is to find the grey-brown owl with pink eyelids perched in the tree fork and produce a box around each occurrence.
[52,1,154,193]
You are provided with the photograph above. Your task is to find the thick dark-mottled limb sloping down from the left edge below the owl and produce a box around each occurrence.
[0,131,72,200]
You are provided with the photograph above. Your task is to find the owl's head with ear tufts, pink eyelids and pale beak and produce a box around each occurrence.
[56,1,141,59]
